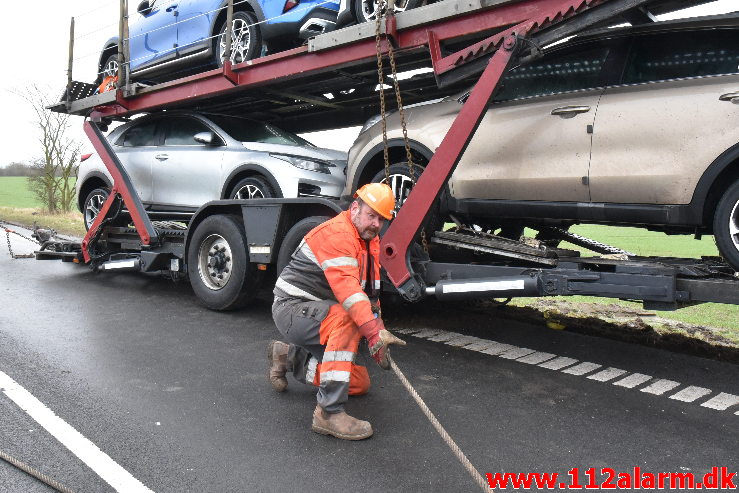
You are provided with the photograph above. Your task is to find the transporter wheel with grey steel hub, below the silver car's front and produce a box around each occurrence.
[187,214,261,310]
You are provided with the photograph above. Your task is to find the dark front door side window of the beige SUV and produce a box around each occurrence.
[495,44,610,101]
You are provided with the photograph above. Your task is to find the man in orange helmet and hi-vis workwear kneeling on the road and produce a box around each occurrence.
[267,183,405,440]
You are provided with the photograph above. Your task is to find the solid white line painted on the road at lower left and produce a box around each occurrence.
[0,371,151,493]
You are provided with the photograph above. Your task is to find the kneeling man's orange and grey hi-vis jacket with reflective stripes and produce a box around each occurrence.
[274,211,380,325]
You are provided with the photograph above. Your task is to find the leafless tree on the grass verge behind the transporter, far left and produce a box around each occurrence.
[19,85,82,212]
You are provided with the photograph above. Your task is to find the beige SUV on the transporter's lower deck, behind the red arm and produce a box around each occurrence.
[345,14,739,270]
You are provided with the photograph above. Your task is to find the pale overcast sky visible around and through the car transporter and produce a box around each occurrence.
[0,0,739,166]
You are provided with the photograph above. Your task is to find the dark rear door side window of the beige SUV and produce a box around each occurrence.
[624,29,739,84]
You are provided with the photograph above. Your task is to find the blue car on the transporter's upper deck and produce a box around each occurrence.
[98,0,339,81]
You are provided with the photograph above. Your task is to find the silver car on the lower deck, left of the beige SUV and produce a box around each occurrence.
[77,111,346,228]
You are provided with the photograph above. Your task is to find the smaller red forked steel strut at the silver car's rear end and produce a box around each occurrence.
[82,116,158,263]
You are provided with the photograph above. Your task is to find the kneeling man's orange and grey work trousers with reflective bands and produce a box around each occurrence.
[272,299,370,413]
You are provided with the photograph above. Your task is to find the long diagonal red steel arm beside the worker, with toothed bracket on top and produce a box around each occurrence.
[380,0,628,301]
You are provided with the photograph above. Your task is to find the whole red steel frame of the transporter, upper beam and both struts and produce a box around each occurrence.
[82,0,624,292]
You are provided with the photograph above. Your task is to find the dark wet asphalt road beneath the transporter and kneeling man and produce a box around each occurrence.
[0,231,739,492]
